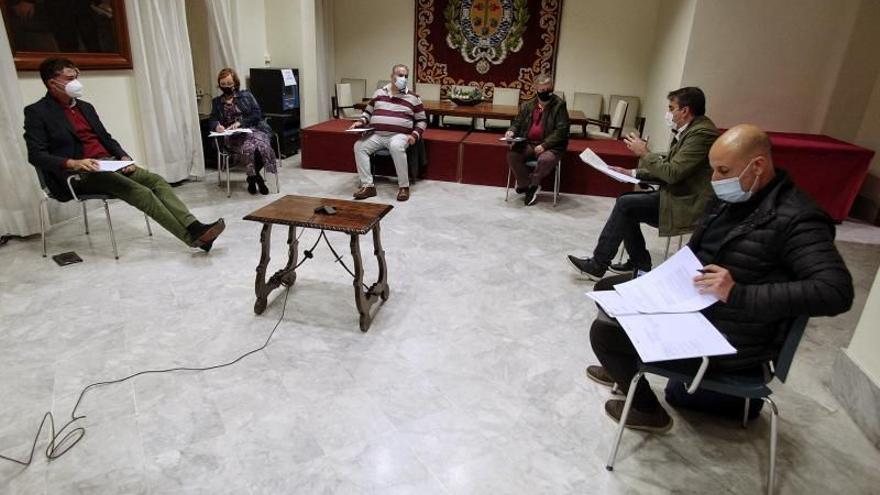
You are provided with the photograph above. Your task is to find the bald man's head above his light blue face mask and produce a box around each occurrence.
[709,124,776,200]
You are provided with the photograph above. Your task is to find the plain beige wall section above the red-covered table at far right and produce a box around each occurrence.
[683,0,859,133]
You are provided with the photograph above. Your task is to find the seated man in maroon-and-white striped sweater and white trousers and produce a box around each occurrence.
[351,64,428,201]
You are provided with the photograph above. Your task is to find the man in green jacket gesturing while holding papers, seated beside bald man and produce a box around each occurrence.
[568,87,719,280]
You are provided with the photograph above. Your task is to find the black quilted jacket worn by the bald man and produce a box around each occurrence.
[689,169,853,367]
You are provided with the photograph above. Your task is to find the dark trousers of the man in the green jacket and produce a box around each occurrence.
[593,191,660,270]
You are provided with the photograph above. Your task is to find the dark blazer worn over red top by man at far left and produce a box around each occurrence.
[24,93,128,201]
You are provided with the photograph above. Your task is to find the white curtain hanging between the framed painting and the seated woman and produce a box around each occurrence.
[125,0,205,182]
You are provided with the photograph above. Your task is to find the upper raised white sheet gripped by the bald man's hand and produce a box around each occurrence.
[614,246,718,313]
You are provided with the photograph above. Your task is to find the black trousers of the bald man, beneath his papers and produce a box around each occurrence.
[590,274,700,413]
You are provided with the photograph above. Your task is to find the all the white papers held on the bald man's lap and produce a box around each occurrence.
[587,247,736,363]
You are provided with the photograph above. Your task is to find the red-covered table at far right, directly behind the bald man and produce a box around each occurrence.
[769,132,874,222]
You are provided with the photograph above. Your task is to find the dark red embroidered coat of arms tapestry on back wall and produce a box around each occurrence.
[415,0,562,99]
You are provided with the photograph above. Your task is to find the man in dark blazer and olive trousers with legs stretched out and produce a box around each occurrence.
[24,57,225,252]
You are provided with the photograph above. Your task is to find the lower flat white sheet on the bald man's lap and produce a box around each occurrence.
[617,313,736,363]
